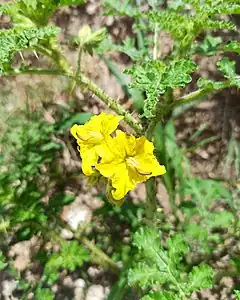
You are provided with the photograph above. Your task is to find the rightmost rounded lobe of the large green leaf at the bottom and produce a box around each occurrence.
[187,265,214,293]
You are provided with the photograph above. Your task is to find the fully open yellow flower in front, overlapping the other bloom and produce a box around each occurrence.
[96,130,166,201]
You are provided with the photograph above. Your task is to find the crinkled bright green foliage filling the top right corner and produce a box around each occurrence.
[149,0,240,55]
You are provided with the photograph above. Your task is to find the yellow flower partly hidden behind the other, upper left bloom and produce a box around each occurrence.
[71,113,123,176]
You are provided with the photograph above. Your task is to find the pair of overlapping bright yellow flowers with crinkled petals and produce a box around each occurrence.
[71,113,166,201]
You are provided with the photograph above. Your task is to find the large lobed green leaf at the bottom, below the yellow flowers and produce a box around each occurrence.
[128,228,213,299]
